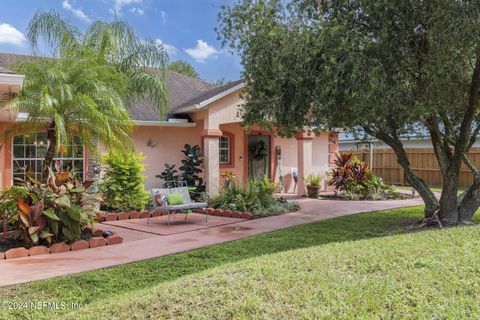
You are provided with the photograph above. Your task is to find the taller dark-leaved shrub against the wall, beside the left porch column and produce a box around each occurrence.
[179,144,206,200]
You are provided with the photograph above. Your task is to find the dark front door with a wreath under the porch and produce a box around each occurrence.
[248,135,271,179]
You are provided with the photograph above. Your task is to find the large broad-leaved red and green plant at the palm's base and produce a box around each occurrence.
[0,161,101,246]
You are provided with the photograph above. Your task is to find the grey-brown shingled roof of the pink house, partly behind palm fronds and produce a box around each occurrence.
[0,53,242,121]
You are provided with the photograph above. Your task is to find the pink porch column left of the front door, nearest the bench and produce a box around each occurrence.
[202,129,222,196]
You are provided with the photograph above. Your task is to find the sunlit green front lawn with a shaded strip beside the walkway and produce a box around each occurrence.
[0,207,480,319]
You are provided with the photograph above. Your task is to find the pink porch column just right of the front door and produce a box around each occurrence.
[295,133,314,196]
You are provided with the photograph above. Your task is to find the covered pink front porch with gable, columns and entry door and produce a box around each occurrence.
[191,90,338,196]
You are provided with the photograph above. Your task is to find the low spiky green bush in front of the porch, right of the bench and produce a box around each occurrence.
[209,177,299,217]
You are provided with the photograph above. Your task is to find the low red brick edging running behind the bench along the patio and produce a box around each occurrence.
[95,208,253,222]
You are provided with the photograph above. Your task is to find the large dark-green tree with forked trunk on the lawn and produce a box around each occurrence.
[218,0,480,225]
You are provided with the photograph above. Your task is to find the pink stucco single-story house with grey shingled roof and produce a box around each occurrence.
[0,54,338,195]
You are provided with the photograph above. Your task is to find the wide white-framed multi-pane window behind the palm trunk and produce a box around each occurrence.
[12,132,85,180]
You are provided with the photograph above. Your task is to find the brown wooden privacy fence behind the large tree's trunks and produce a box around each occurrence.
[348,148,480,188]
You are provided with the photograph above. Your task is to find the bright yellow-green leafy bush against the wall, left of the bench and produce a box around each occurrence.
[100,152,149,211]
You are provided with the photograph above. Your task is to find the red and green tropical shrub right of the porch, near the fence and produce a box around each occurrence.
[328,153,400,200]
